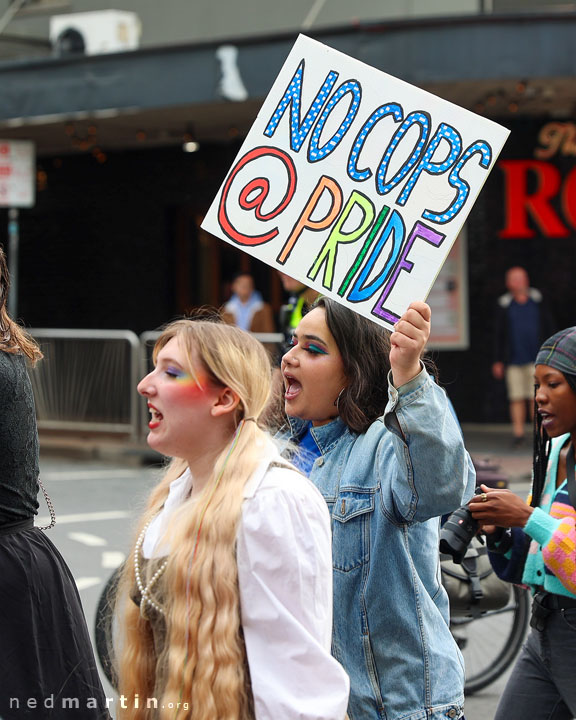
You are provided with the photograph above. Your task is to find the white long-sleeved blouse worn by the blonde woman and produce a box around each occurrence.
[142,448,349,720]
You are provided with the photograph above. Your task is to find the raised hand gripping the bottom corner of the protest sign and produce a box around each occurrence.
[390,302,431,387]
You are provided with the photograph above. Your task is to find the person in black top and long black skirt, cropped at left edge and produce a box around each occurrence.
[0,248,110,720]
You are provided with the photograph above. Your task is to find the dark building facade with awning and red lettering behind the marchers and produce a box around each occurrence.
[0,0,576,422]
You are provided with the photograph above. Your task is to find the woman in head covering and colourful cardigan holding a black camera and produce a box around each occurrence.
[470,327,576,720]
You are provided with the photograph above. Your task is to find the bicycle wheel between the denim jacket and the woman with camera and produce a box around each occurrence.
[450,585,530,695]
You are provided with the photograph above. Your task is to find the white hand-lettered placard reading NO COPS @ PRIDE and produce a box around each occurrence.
[202,35,508,327]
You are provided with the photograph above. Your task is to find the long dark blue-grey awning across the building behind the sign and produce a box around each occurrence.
[0,14,576,155]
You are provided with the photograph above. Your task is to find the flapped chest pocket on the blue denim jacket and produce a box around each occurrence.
[332,490,375,572]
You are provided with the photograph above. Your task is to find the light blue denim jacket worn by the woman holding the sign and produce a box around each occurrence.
[285,370,476,720]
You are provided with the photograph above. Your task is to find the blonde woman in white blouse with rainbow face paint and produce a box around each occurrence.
[112,319,348,720]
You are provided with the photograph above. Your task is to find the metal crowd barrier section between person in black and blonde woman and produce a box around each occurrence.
[29,328,141,439]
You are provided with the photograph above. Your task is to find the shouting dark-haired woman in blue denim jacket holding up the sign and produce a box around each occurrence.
[282,298,475,720]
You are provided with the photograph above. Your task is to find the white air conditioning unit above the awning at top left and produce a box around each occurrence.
[50,10,142,56]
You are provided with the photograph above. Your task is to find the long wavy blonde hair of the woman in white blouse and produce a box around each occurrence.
[117,319,272,720]
